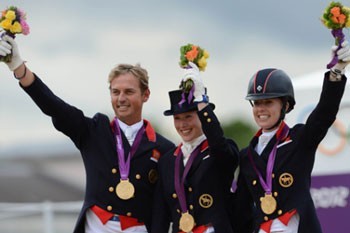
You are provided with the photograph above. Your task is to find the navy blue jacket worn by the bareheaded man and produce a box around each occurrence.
[24,77,174,233]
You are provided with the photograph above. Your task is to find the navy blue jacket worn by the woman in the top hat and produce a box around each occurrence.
[151,106,238,233]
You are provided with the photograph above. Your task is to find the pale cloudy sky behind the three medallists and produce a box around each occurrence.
[0,0,350,156]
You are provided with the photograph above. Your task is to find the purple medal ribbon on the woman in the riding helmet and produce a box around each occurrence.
[248,122,289,194]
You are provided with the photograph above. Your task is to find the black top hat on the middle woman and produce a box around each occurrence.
[164,90,215,116]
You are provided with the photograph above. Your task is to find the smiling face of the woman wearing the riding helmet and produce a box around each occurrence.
[252,98,283,132]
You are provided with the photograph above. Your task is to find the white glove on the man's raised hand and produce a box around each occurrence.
[0,35,24,71]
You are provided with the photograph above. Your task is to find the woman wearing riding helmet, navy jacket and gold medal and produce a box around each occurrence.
[233,41,350,233]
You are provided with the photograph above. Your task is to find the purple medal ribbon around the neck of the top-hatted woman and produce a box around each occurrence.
[175,143,202,213]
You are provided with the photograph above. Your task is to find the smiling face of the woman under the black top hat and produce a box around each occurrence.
[174,111,203,142]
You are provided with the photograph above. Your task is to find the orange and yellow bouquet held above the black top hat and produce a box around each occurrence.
[179,44,209,93]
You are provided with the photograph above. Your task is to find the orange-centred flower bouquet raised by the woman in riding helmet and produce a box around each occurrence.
[321,2,350,69]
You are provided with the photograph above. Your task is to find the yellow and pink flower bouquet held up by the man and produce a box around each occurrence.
[0,6,29,62]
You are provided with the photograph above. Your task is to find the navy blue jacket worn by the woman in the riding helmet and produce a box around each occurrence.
[233,73,346,233]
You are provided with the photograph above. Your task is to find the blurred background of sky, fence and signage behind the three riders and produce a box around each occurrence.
[0,0,350,233]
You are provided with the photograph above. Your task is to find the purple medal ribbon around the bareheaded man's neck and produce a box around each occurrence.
[114,118,145,180]
